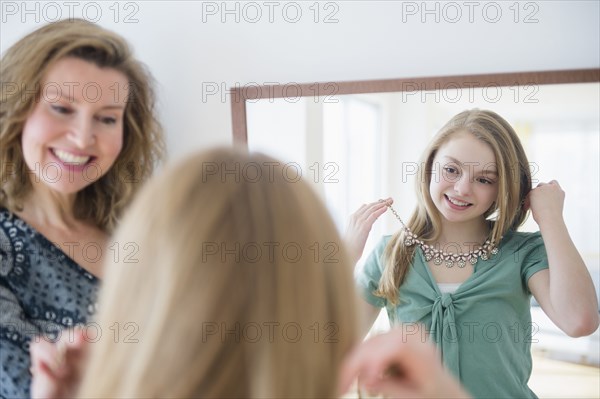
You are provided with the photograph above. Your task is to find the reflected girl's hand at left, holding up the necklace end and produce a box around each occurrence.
[344,198,394,264]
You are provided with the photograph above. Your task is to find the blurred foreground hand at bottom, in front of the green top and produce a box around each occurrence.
[338,328,469,398]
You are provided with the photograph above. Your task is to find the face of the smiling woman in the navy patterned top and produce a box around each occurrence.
[21,57,128,194]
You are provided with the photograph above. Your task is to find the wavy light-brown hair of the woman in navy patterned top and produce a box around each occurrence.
[0,19,164,231]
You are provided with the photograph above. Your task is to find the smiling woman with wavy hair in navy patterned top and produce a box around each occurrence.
[0,20,163,398]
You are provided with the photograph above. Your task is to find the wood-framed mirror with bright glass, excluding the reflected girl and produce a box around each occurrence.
[231,69,600,390]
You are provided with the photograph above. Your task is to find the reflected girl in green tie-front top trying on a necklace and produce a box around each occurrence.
[347,110,599,398]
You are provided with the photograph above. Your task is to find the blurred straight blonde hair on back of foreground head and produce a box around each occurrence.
[79,149,357,398]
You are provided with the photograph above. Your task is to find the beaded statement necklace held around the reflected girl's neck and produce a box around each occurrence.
[379,200,498,268]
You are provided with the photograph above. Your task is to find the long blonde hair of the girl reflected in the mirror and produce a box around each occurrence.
[375,109,531,305]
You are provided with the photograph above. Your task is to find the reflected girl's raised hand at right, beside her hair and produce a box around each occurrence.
[524,180,565,225]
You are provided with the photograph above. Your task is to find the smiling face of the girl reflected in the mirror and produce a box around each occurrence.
[429,132,498,222]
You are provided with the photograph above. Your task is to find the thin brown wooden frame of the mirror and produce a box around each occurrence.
[230,69,600,148]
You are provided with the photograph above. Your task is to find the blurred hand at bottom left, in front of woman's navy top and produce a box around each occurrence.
[30,329,87,399]
